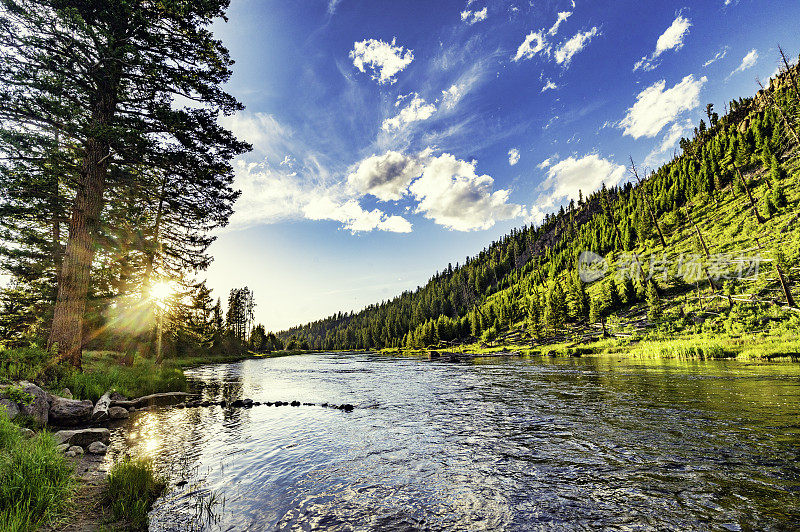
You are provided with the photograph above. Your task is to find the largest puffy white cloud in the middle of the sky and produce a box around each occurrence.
[410,153,523,231]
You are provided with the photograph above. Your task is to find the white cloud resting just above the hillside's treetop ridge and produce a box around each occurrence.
[532,153,625,208]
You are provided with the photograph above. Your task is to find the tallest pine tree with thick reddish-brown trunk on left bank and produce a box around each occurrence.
[0,0,248,367]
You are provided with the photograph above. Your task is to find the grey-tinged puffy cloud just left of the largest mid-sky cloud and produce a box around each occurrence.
[347,150,429,201]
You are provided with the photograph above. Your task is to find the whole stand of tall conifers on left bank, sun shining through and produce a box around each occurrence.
[0,0,252,367]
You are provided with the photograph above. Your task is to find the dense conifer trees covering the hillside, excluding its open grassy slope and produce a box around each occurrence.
[280,52,800,349]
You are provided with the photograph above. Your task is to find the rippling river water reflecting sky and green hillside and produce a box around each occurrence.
[111,354,800,531]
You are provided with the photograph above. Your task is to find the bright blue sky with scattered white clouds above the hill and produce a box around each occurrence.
[197,0,800,330]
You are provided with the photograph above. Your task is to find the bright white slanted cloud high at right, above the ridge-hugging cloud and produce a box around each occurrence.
[619,74,708,139]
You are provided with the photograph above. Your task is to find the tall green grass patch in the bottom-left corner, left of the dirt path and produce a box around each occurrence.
[0,412,75,532]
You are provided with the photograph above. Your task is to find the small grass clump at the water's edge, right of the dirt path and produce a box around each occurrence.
[105,459,167,530]
